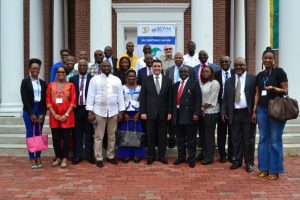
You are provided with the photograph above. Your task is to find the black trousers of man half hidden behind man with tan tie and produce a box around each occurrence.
[217,117,233,159]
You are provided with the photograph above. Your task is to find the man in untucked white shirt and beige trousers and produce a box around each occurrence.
[86,60,125,167]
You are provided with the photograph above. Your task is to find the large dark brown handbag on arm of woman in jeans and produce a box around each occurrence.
[268,96,299,121]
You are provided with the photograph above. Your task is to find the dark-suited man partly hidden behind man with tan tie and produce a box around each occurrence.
[215,56,234,163]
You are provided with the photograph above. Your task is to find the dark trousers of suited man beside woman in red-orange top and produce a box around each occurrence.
[74,106,94,159]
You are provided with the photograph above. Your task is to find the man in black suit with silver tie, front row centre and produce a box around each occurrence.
[140,60,172,165]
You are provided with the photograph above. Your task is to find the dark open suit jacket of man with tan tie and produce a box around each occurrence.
[221,72,256,124]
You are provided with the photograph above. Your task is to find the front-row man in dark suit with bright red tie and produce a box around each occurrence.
[172,66,202,168]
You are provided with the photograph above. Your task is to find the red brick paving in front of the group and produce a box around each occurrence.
[0,157,300,200]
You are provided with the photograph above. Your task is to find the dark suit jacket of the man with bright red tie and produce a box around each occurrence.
[172,78,202,125]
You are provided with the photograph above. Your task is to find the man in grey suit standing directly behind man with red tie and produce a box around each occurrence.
[165,52,195,148]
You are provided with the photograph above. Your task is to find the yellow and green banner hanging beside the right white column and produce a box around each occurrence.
[270,0,279,49]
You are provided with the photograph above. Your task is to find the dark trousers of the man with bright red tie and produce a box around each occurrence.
[174,124,197,163]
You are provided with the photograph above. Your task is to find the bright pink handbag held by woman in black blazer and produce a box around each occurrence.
[26,124,48,153]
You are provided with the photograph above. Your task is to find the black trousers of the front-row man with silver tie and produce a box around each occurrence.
[146,116,167,159]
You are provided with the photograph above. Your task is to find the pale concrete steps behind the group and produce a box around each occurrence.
[0,117,300,157]
